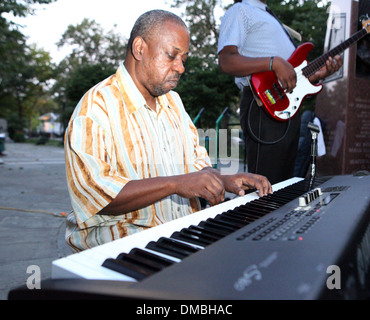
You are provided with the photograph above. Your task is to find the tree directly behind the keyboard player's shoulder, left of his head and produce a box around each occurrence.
[53,19,127,127]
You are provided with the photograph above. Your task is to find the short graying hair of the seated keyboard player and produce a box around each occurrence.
[127,10,187,56]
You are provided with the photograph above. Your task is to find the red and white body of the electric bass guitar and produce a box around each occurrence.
[251,42,322,121]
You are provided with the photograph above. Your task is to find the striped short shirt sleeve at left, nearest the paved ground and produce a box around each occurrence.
[65,105,129,228]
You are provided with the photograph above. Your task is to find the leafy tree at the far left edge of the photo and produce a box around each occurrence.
[0,0,55,140]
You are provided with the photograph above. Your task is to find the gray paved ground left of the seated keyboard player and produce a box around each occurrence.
[0,143,72,300]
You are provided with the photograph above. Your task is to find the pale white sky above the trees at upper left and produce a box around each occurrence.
[7,0,231,63]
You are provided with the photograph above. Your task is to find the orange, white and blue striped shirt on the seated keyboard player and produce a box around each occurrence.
[65,63,211,251]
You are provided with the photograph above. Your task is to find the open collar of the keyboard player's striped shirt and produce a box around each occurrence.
[116,62,169,114]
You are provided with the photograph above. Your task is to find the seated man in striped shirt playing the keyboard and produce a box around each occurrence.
[65,10,272,251]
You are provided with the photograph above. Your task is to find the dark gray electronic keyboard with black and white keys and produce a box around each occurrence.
[9,175,370,300]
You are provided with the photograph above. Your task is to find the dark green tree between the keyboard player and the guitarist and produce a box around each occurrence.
[172,0,239,128]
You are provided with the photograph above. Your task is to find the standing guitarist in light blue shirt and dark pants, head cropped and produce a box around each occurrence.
[218,0,343,183]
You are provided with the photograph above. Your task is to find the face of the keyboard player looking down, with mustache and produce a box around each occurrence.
[141,22,189,97]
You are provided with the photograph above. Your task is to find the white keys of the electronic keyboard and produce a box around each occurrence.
[52,178,302,281]
